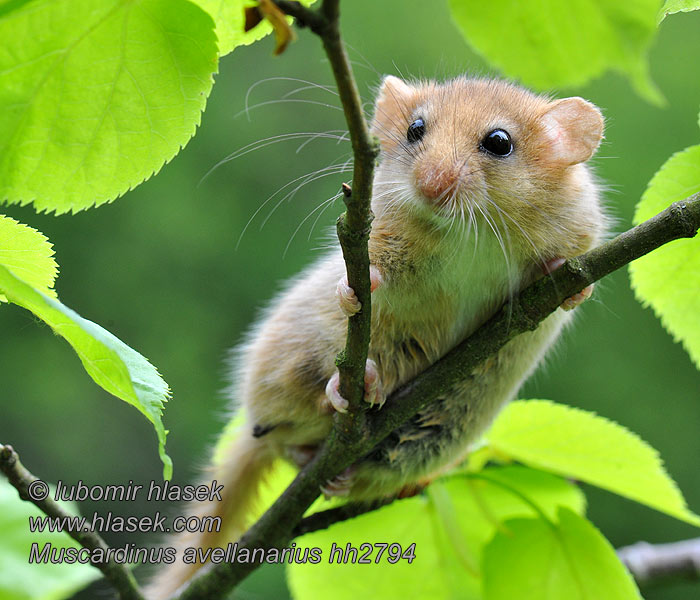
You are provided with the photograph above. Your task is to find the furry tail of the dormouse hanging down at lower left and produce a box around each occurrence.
[145,428,275,600]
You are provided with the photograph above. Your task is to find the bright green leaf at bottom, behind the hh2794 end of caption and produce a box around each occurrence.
[287,466,584,600]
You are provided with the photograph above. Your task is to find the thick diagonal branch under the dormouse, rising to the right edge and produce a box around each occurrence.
[180,194,700,600]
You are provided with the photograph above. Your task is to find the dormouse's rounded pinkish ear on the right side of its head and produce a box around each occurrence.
[540,98,603,166]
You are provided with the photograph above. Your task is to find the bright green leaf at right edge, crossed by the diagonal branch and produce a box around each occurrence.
[629,145,700,368]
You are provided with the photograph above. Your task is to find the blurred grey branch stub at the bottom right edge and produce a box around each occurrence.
[617,538,700,587]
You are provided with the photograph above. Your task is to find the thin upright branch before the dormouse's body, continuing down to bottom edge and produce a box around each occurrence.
[180,0,379,600]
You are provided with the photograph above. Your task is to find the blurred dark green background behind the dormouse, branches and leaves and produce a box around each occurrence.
[0,0,700,600]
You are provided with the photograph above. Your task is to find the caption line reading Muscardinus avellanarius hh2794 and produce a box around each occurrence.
[29,542,416,565]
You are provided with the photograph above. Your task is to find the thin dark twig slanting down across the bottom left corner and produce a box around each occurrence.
[0,445,144,600]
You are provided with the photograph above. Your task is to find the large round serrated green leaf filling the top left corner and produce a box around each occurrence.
[0,0,217,213]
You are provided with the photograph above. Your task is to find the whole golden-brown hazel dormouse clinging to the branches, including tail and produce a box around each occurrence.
[148,76,606,599]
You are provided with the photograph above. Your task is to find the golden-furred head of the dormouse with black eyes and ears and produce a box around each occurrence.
[372,76,603,255]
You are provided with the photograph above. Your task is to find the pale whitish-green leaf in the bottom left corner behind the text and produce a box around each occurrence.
[0,478,101,600]
